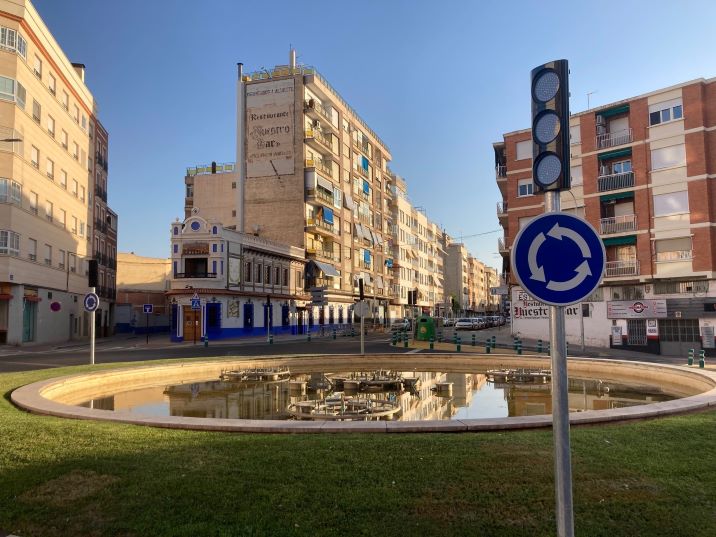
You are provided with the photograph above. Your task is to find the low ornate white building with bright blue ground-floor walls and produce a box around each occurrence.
[167,214,306,341]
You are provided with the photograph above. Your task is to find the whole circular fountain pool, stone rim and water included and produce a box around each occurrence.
[12,354,716,432]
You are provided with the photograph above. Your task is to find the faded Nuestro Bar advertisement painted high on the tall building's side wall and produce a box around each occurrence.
[246,78,295,178]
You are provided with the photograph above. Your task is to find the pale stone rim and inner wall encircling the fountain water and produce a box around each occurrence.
[11,353,716,433]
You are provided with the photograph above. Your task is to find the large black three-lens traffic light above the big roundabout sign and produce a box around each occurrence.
[531,60,570,192]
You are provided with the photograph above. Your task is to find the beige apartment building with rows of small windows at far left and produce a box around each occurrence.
[0,0,116,344]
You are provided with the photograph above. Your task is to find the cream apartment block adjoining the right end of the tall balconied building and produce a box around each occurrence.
[389,172,445,317]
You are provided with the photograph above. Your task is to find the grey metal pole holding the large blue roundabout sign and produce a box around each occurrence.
[544,191,574,537]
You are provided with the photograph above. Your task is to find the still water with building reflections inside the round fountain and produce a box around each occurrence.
[80,370,673,421]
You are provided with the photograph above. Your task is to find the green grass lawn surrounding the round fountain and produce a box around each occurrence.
[0,360,716,537]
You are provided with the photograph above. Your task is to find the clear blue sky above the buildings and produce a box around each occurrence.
[35,0,716,268]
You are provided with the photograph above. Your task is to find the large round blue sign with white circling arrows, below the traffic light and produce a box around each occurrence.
[511,213,606,306]
